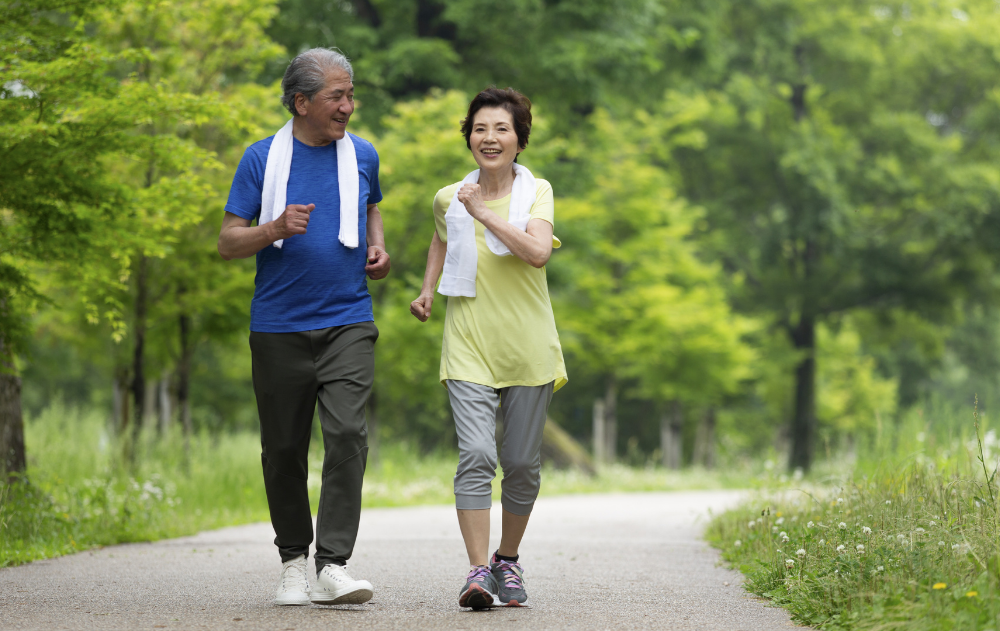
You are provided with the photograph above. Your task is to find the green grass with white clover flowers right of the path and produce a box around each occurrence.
[708,420,1000,631]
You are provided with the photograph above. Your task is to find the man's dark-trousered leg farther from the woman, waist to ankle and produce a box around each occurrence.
[250,333,318,562]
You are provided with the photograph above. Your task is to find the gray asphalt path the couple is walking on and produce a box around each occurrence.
[0,491,794,631]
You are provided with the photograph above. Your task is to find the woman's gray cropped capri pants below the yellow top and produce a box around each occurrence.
[446,379,555,515]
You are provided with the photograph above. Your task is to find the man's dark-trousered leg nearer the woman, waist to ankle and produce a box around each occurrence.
[310,322,378,573]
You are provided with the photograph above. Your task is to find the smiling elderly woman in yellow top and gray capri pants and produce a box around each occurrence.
[410,88,566,609]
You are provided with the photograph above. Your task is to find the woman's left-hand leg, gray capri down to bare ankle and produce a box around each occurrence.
[446,380,500,565]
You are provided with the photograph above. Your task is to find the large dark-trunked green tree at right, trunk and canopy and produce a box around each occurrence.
[658,0,1000,470]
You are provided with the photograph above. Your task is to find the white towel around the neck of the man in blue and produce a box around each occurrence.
[257,119,359,249]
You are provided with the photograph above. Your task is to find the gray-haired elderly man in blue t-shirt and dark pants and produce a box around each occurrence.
[219,48,389,605]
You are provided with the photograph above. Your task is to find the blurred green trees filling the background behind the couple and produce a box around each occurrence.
[0,0,1000,470]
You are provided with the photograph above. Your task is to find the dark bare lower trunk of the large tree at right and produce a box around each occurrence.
[788,315,816,472]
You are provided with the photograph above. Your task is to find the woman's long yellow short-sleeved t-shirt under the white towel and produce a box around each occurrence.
[434,179,567,390]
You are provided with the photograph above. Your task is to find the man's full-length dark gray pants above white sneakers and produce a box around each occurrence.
[250,322,378,571]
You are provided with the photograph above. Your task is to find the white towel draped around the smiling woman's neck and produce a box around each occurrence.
[438,162,535,298]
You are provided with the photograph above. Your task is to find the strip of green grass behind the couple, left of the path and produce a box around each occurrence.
[0,404,746,567]
